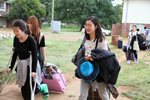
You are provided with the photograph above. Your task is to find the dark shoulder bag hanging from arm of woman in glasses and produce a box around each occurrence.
[71,37,86,66]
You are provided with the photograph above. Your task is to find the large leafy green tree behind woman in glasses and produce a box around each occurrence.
[48,0,118,28]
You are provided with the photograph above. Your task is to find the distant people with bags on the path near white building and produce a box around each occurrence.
[127,25,150,64]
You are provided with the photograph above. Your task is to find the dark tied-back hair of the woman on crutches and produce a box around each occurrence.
[12,19,30,35]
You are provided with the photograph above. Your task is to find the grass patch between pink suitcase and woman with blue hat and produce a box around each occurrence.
[46,39,81,72]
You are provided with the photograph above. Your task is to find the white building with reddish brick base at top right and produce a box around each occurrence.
[121,0,150,37]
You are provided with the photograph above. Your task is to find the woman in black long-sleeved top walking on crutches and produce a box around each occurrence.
[7,19,47,100]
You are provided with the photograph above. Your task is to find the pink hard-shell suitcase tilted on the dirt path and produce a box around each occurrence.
[42,69,67,92]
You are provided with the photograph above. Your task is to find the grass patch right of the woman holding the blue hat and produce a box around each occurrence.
[117,52,150,100]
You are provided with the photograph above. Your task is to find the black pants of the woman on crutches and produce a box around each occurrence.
[21,67,40,100]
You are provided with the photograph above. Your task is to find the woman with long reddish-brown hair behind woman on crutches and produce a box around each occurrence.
[27,16,46,71]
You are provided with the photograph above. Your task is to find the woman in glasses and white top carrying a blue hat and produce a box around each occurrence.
[79,16,109,100]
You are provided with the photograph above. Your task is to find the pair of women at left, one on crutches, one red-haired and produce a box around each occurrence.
[7,16,48,100]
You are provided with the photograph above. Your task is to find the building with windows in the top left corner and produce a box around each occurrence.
[0,0,11,27]
